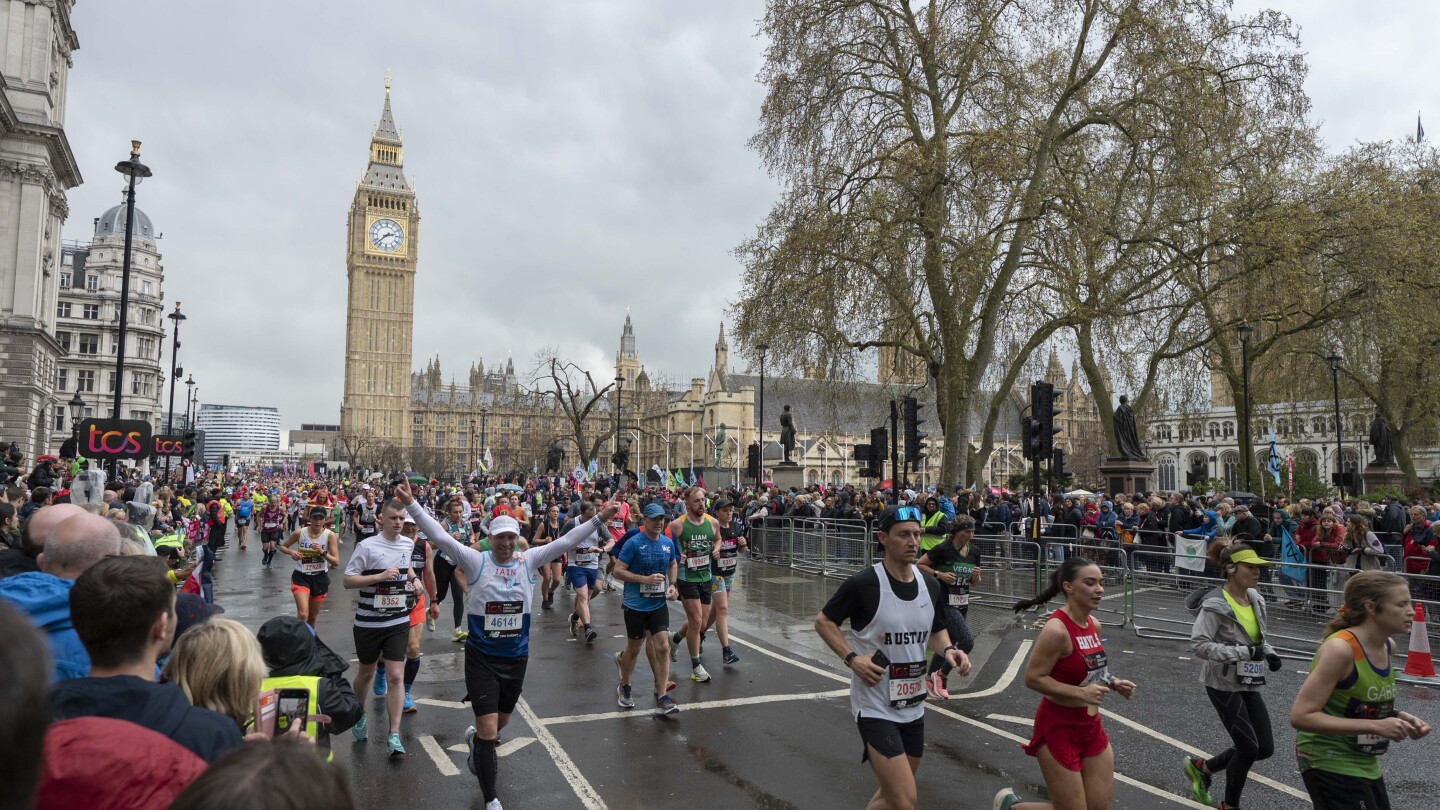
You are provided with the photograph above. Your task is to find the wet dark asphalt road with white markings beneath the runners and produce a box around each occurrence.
[208,543,1440,810]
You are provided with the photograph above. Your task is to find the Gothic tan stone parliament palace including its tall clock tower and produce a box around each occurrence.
[337,78,1099,486]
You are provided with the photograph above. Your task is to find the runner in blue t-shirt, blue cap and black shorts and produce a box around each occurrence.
[615,503,680,715]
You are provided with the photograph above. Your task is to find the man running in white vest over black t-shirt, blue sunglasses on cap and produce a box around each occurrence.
[815,506,971,807]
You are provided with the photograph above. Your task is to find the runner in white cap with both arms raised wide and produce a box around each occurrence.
[394,484,615,810]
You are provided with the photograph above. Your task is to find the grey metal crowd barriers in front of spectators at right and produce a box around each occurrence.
[749,517,1440,680]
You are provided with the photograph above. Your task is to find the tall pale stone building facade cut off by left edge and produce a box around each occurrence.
[0,0,81,458]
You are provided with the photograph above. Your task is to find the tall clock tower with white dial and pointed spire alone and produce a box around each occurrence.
[340,74,420,447]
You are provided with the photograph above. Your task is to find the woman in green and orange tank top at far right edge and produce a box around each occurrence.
[1290,571,1430,810]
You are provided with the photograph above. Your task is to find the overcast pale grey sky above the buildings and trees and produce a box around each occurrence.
[65,0,1440,428]
